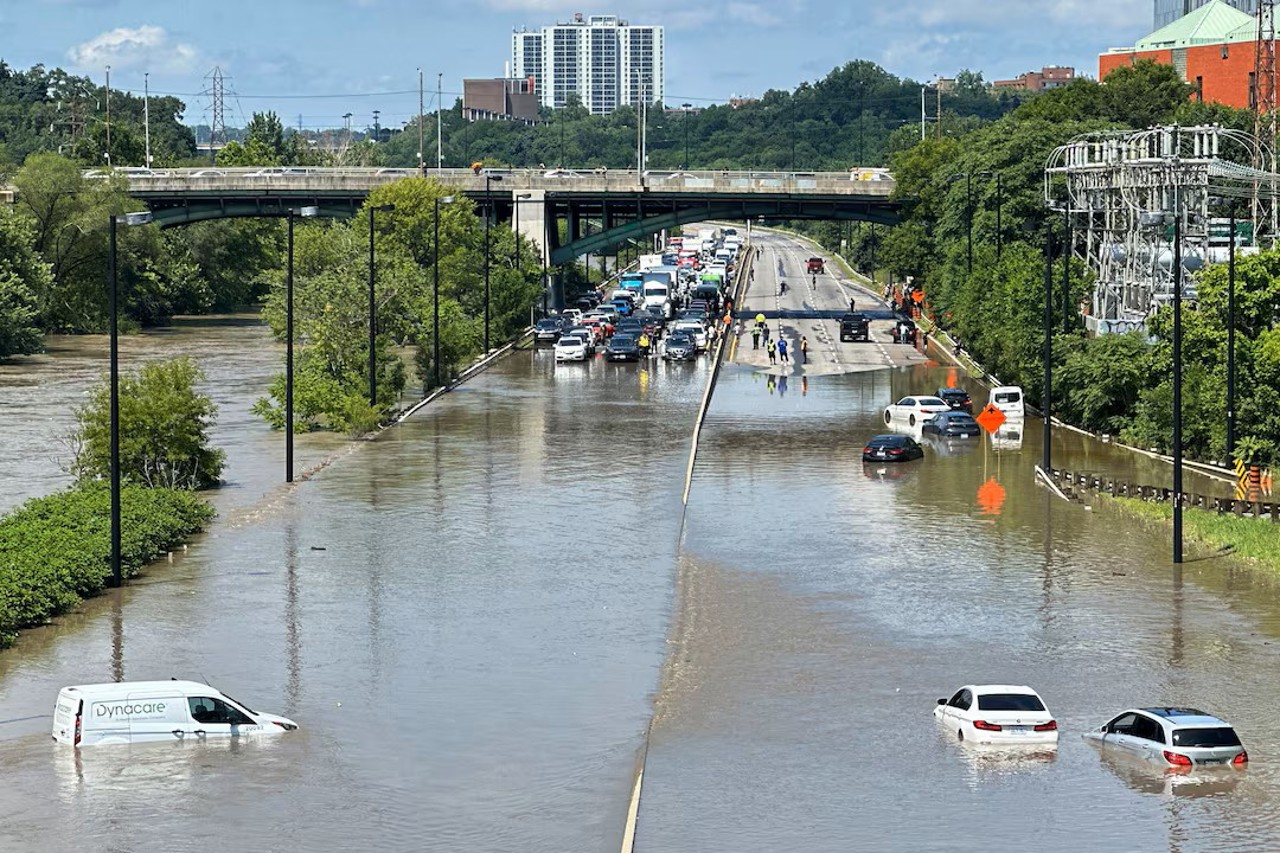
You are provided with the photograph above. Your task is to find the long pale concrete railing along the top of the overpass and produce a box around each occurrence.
[110,167,895,197]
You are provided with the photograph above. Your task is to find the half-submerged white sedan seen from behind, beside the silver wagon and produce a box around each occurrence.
[933,684,1057,744]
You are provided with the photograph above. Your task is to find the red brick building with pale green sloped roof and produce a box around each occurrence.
[1098,0,1280,109]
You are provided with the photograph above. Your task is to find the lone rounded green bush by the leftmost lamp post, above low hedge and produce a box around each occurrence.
[72,359,225,489]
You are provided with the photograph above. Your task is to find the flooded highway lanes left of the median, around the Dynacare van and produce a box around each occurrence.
[0,351,705,853]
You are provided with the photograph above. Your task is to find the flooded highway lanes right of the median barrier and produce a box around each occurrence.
[637,368,1280,850]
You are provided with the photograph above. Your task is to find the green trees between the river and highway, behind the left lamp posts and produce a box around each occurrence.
[255,178,541,434]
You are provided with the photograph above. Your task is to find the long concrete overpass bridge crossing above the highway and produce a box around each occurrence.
[117,167,899,265]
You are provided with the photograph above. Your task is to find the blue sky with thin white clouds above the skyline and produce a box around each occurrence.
[0,0,1152,128]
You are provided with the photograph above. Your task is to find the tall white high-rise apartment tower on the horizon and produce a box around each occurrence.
[511,14,663,114]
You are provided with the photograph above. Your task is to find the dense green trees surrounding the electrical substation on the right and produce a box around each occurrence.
[810,63,1280,462]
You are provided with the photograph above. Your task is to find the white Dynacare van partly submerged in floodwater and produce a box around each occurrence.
[54,681,298,747]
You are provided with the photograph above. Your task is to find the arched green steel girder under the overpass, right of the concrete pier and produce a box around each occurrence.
[550,200,900,265]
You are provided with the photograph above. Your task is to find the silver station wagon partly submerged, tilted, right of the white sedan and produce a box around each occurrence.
[1084,708,1249,768]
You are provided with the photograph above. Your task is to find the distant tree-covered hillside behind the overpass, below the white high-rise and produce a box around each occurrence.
[379,60,1025,172]
